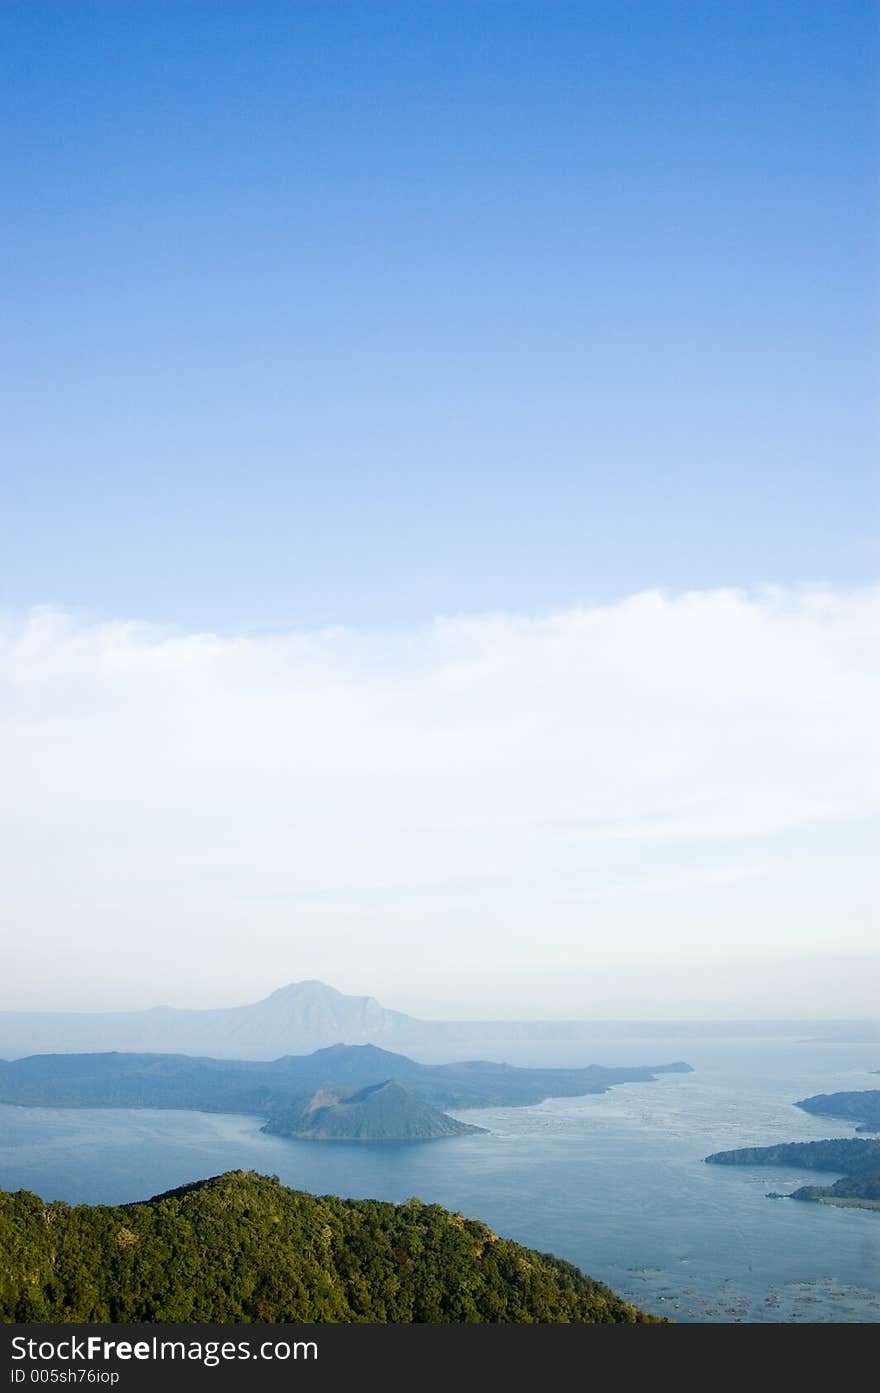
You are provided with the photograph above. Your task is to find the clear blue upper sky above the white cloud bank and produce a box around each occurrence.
[0,0,879,630]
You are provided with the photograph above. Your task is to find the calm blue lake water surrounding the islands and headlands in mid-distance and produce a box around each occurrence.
[0,1036,880,1322]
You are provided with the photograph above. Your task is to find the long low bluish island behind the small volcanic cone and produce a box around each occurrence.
[0,1045,689,1139]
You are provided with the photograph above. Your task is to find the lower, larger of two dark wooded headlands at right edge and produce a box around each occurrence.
[706,1137,880,1209]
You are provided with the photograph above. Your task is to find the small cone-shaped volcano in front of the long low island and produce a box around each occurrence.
[263,1081,485,1141]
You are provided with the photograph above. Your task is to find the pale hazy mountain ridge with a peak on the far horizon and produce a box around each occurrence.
[0,981,870,1060]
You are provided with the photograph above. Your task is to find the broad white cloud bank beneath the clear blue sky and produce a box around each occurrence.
[0,589,880,1014]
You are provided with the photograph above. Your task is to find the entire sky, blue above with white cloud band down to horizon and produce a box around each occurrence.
[0,0,880,1018]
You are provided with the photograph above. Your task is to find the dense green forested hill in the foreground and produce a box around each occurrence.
[0,1172,654,1323]
